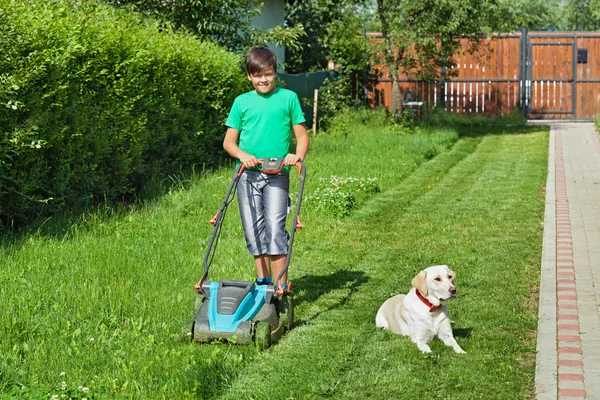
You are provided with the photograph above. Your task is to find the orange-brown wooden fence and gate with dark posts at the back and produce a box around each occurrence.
[367,30,600,120]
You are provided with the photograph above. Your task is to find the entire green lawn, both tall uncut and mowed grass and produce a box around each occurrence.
[0,113,548,399]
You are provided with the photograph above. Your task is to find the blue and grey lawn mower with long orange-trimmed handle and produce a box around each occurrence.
[192,158,306,350]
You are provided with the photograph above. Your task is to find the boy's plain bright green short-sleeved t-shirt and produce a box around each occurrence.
[225,88,306,162]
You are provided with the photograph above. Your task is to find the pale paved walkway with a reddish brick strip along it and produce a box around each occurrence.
[536,123,600,400]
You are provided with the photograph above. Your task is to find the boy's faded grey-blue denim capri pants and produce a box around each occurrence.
[236,170,290,256]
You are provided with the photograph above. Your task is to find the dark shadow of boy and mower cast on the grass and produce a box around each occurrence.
[293,270,369,326]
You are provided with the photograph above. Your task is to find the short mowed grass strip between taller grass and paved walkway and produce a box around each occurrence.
[217,130,547,399]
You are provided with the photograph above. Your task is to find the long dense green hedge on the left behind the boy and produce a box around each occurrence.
[0,0,247,229]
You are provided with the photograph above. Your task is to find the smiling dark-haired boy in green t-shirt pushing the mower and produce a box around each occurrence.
[223,47,310,293]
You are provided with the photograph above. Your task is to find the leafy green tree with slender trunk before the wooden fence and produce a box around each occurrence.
[377,0,499,114]
